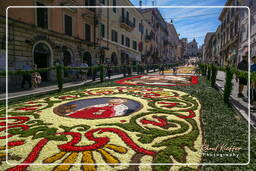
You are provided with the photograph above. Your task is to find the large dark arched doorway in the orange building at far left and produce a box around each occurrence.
[34,42,51,81]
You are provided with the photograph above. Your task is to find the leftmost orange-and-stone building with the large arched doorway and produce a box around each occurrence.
[0,0,96,84]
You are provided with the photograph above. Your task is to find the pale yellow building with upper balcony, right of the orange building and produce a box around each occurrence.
[96,0,143,65]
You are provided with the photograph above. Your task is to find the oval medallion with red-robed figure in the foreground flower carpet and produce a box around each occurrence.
[53,97,142,119]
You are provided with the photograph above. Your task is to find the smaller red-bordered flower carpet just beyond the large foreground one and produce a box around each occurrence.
[116,75,198,86]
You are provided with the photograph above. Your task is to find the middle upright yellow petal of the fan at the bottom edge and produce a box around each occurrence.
[82,151,97,171]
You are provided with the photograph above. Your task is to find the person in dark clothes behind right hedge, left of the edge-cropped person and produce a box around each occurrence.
[236,55,248,98]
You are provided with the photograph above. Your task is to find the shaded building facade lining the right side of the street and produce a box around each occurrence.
[204,0,256,66]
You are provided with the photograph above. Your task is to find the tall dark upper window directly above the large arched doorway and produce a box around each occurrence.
[36,2,48,29]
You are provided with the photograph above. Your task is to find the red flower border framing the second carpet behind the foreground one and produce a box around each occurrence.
[115,75,198,86]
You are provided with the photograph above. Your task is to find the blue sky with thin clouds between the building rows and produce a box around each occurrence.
[130,0,226,45]
